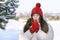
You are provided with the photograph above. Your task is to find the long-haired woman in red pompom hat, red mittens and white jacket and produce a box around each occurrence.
[19,3,53,40]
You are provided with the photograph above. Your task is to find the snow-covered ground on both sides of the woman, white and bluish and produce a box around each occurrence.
[0,19,60,40]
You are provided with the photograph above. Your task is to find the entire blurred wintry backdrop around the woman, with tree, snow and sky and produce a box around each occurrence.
[0,0,60,40]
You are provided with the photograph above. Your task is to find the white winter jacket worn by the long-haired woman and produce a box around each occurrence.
[19,25,54,40]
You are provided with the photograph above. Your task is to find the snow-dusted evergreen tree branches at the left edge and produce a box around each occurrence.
[0,0,19,29]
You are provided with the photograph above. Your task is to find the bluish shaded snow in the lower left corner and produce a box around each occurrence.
[0,30,19,40]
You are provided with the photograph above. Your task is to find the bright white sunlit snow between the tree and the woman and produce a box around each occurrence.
[6,19,26,30]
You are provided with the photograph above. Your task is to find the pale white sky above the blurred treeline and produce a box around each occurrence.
[16,0,60,13]
